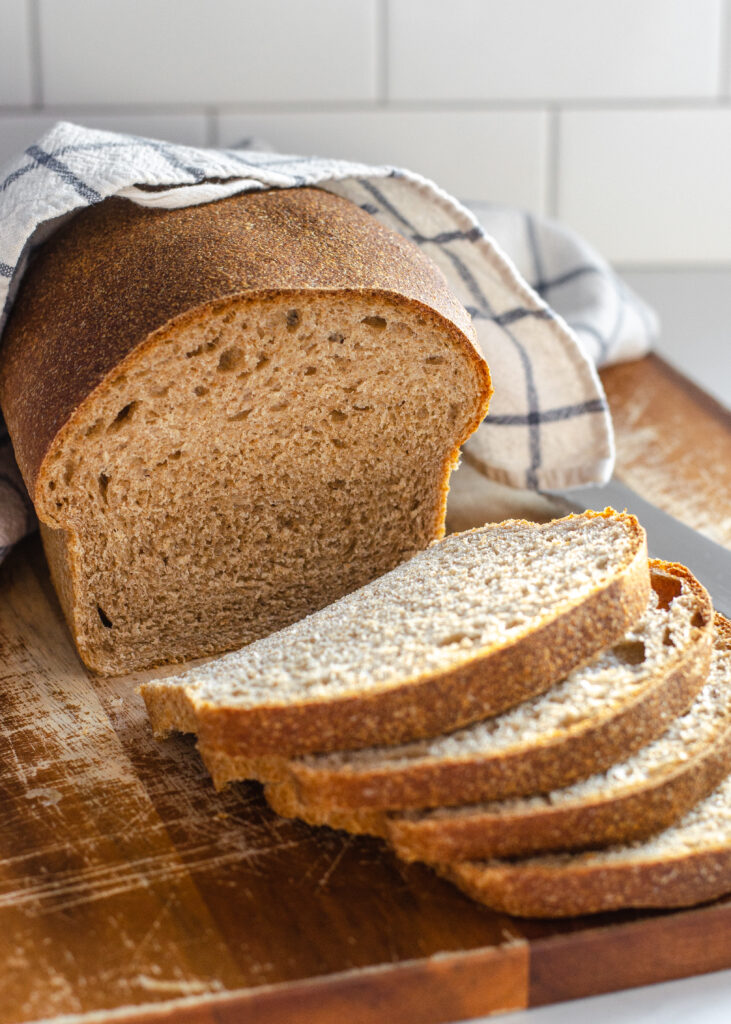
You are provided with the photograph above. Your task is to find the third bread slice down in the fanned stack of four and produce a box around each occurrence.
[387,617,731,863]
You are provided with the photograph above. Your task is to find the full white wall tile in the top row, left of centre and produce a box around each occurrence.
[40,0,377,104]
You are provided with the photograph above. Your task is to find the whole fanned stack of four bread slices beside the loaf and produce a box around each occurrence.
[142,509,731,916]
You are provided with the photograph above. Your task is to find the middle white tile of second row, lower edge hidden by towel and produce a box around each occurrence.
[220,111,547,210]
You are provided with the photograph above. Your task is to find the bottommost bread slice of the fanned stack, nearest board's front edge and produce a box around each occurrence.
[437,621,731,918]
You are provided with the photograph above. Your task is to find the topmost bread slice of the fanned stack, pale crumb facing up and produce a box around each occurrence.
[141,509,650,761]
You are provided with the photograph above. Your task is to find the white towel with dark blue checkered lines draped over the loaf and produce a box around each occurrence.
[0,123,656,557]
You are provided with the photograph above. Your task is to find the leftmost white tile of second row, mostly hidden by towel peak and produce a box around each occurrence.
[0,111,207,164]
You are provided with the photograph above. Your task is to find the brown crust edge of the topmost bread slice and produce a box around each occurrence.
[150,509,650,761]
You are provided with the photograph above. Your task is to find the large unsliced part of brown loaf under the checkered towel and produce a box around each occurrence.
[0,188,490,673]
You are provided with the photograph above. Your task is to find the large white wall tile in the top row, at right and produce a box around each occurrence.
[388,0,723,100]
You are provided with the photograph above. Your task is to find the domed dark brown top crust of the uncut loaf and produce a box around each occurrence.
[0,188,489,495]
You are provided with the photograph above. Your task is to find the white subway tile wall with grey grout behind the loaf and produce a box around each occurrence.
[0,0,731,264]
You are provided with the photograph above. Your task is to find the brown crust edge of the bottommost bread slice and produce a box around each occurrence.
[435,849,731,918]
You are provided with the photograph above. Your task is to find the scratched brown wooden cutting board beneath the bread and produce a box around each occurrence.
[0,359,731,1024]
